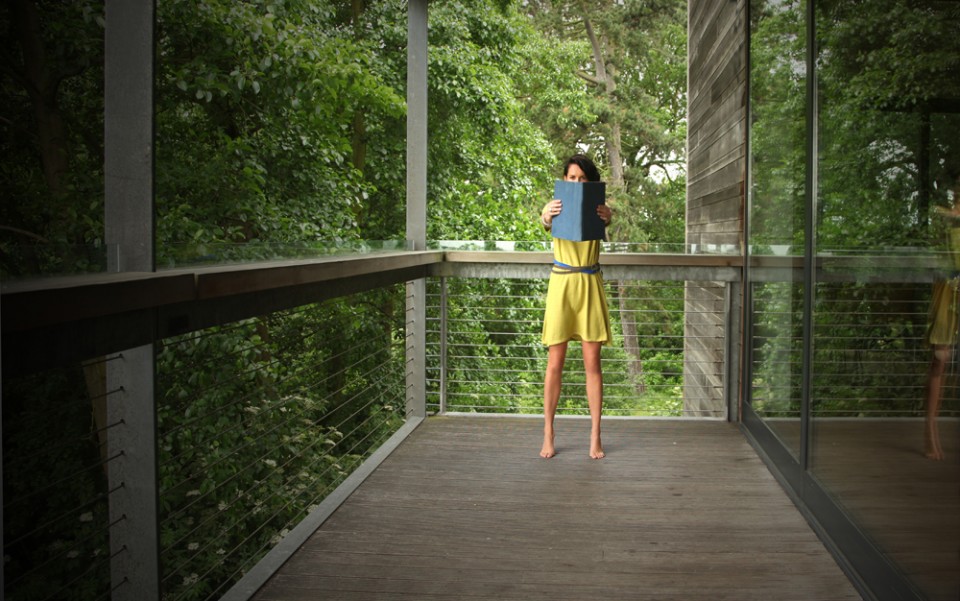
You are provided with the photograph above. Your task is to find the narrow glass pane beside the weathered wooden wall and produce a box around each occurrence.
[748,0,806,456]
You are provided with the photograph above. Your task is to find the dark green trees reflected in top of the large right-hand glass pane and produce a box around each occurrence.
[817,0,960,249]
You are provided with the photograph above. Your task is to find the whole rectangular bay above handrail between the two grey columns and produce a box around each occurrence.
[155,0,406,268]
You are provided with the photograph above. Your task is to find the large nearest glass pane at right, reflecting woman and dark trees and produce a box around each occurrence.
[810,0,960,600]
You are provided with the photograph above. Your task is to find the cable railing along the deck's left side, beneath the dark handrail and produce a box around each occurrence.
[3,272,407,601]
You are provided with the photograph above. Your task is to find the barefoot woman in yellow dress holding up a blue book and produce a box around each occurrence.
[540,155,613,459]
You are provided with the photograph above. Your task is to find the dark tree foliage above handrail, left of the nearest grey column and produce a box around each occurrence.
[0,1,106,281]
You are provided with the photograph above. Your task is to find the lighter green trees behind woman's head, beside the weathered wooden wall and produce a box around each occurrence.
[525,0,686,243]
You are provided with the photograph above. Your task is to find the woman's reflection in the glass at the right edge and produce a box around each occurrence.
[923,179,960,459]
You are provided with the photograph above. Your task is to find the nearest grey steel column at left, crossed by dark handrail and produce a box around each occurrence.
[104,0,160,601]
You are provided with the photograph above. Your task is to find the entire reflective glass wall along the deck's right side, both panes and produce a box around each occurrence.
[746,0,960,600]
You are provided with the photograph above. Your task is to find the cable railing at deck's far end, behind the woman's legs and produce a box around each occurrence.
[427,280,712,416]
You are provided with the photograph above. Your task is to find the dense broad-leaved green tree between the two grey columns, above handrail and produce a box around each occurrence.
[157,0,403,264]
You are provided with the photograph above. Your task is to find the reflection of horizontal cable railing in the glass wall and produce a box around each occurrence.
[751,281,960,419]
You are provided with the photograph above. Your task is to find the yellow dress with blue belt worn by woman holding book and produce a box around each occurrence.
[542,238,613,346]
